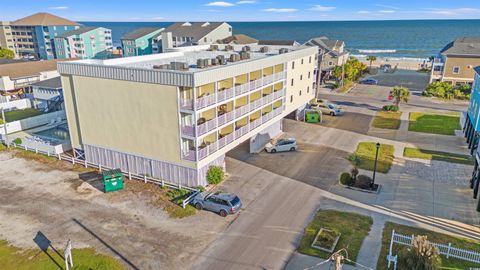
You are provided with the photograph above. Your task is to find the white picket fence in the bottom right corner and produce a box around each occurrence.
[389,230,480,263]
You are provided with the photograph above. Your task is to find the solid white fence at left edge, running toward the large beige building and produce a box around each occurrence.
[0,110,66,134]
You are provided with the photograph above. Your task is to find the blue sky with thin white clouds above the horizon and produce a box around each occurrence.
[0,0,480,21]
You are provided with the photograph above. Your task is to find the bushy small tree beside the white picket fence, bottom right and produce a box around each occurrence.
[398,236,442,270]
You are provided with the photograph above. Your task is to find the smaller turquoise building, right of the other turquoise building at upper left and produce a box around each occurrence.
[121,27,164,57]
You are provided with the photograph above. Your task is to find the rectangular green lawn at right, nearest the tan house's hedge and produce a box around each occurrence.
[408,112,461,135]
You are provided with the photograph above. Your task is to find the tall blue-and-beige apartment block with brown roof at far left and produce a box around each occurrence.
[10,13,80,60]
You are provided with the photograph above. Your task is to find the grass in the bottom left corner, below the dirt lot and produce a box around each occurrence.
[0,240,124,270]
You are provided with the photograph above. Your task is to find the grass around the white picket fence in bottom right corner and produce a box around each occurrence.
[376,222,480,270]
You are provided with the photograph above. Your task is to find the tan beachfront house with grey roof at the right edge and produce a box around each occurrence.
[430,37,480,86]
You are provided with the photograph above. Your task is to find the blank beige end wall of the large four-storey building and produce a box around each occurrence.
[62,76,194,167]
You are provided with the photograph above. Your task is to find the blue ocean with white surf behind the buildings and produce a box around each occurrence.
[80,20,480,60]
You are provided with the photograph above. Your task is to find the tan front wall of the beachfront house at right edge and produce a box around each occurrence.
[443,56,480,82]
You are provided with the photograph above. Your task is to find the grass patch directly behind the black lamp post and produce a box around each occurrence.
[354,142,395,173]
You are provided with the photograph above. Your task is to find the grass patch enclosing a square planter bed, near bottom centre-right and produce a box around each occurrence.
[298,210,373,261]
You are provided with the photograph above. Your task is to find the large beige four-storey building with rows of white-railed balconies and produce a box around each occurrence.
[58,44,318,186]
